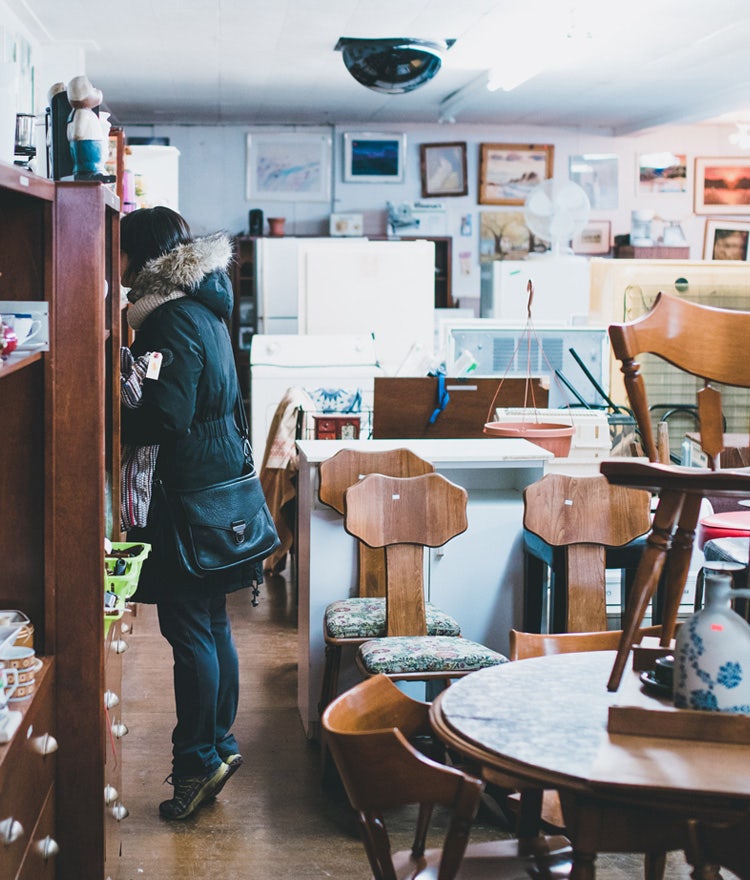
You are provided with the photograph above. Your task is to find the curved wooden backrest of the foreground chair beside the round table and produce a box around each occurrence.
[321,675,482,880]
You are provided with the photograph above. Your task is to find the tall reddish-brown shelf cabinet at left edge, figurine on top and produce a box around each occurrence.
[0,164,121,880]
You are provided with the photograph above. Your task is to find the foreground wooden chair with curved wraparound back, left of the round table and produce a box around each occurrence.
[321,675,571,880]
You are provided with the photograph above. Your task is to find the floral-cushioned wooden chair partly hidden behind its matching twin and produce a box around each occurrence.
[318,449,461,712]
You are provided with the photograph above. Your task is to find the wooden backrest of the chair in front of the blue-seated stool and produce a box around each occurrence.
[523,474,651,632]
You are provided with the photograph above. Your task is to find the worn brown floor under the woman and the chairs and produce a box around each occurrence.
[112,576,712,880]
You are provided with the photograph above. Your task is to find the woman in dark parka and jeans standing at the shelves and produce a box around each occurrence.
[120,207,262,819]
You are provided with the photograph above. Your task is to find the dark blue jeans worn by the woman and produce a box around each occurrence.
[156,595,239,777]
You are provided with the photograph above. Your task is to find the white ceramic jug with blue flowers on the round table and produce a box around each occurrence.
[674,570,750,715]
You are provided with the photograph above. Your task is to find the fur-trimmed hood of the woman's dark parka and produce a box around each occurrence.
[128,232,234,327]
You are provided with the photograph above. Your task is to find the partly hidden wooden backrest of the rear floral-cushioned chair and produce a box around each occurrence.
[318,449,435,597]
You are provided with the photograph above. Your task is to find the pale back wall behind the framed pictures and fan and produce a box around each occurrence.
[126,118,747,306]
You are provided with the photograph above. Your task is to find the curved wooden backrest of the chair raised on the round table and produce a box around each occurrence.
[609,293,750,467]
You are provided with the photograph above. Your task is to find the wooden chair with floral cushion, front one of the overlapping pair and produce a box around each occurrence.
[344,474,507,685]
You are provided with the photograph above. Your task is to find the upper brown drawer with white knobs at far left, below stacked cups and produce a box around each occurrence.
[0,662,57,878]
